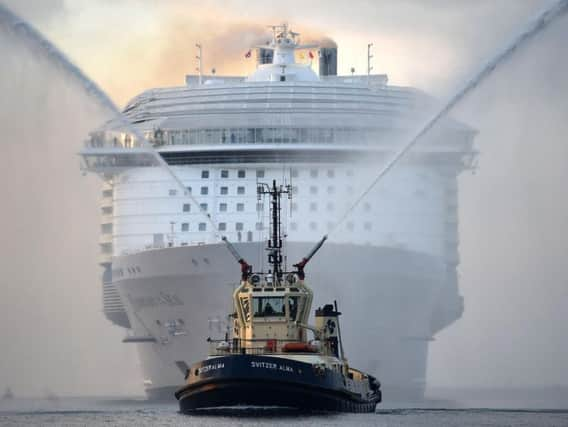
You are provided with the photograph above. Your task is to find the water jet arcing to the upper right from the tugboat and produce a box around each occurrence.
[328,0,568,235]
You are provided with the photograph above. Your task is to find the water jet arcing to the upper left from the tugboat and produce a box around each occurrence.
[0,3,217,233]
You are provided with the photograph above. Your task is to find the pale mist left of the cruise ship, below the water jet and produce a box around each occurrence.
[0,20,140,397]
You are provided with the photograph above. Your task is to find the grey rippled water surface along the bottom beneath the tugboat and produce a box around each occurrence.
[0,399,568,427]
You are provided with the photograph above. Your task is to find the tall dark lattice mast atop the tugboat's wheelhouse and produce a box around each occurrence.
[257,180,292,282]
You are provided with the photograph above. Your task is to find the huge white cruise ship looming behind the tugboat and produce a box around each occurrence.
[80,25,476,401]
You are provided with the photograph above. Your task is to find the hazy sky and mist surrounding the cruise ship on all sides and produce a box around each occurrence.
[0,1,568,402]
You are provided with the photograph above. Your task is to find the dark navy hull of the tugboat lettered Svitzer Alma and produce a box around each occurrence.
[176,355,381,413]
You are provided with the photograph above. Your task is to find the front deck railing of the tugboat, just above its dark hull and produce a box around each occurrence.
[207,338,320,356]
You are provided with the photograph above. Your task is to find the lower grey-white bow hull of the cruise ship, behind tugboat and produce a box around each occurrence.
[113,242,462,401]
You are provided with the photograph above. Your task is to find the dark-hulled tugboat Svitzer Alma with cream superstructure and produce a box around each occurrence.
[175,181,382,413]
